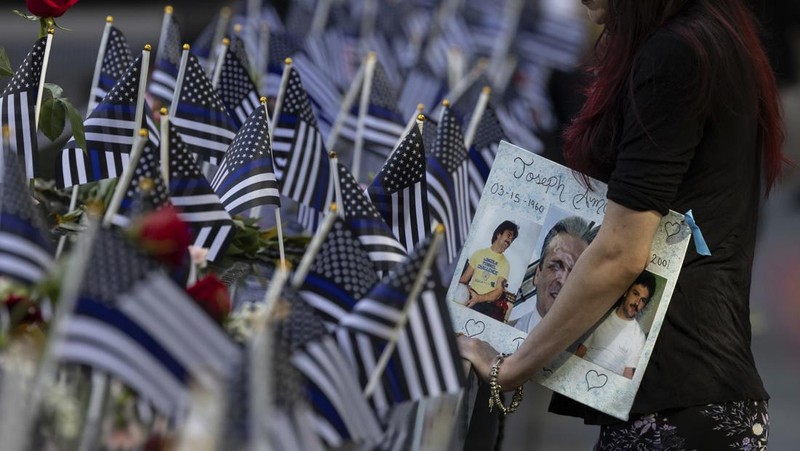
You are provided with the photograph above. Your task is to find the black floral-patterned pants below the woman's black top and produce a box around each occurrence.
[594,401,769,451]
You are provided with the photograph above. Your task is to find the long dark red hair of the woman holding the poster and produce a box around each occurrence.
[564,0,784,192]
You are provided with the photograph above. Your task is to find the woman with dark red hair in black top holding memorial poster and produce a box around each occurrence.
[459,0,783,450]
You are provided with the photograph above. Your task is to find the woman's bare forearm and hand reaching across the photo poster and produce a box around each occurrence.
[458,200,661,390]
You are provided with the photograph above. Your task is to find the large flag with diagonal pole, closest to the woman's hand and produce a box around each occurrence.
[336,235,464,415]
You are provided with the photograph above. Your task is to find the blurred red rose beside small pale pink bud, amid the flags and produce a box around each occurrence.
[135,205,192,269]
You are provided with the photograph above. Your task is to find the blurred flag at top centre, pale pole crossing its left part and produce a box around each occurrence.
[341,60,406,160]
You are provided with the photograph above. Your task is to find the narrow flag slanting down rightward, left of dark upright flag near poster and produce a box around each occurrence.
[337,163,407,273]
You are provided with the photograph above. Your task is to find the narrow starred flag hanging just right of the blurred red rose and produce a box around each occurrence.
[162,124,233,262]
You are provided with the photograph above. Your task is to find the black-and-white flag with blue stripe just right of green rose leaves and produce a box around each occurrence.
[55,55,159,188]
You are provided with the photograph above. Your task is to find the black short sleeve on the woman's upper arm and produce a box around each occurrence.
[608,31,704,215]
